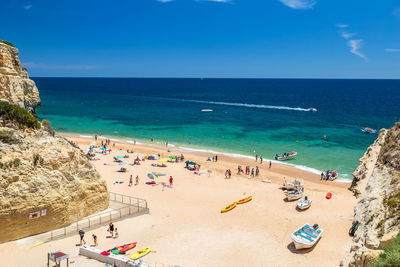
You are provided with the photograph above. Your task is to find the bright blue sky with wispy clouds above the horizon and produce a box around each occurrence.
[0,0,400,78]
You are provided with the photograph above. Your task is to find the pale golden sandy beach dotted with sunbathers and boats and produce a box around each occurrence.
[0,134,356,266]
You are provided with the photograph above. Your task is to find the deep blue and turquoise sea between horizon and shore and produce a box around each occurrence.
[33,78,400,178]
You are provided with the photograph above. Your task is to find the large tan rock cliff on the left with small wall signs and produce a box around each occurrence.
[0,40,109,243]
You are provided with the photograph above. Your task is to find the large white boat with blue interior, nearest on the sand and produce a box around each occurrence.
[291,223,324,250]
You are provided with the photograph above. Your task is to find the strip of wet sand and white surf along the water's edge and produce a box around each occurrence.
[58,132,352,188]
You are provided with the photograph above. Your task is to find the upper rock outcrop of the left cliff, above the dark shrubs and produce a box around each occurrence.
[0,42,40,113]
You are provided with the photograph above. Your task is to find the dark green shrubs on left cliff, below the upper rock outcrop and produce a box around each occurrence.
[0,101,41,129]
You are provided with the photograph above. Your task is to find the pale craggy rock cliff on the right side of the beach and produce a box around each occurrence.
[348,123,400,266]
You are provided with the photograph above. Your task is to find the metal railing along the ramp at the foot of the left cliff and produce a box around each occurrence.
[42,192,149,242]
